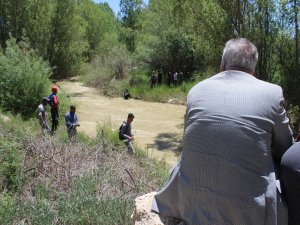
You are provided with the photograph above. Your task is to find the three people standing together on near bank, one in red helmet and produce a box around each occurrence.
[36,85,80,141]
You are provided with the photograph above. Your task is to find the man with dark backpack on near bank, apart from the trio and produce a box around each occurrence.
[119,113,134,154]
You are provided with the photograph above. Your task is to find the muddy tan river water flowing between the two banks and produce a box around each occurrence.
[59,81,185,165]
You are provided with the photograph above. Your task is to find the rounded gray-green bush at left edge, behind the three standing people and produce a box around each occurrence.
[0,38,50,115]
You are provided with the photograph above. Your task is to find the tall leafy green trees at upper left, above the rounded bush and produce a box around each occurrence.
[0,0,117,77]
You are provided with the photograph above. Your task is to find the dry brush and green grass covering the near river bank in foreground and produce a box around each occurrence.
[0,110,168,225]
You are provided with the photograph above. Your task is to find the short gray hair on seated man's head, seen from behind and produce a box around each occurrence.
[222,38,258,72]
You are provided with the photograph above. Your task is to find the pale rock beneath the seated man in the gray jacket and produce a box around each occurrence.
[131,192,184,225]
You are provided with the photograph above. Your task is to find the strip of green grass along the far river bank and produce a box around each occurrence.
[80,62,205,104]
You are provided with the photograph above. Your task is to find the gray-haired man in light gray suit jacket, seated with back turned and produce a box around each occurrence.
[152,38,293,225]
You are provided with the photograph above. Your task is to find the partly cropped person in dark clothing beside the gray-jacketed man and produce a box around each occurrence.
[280,142,300,225]
